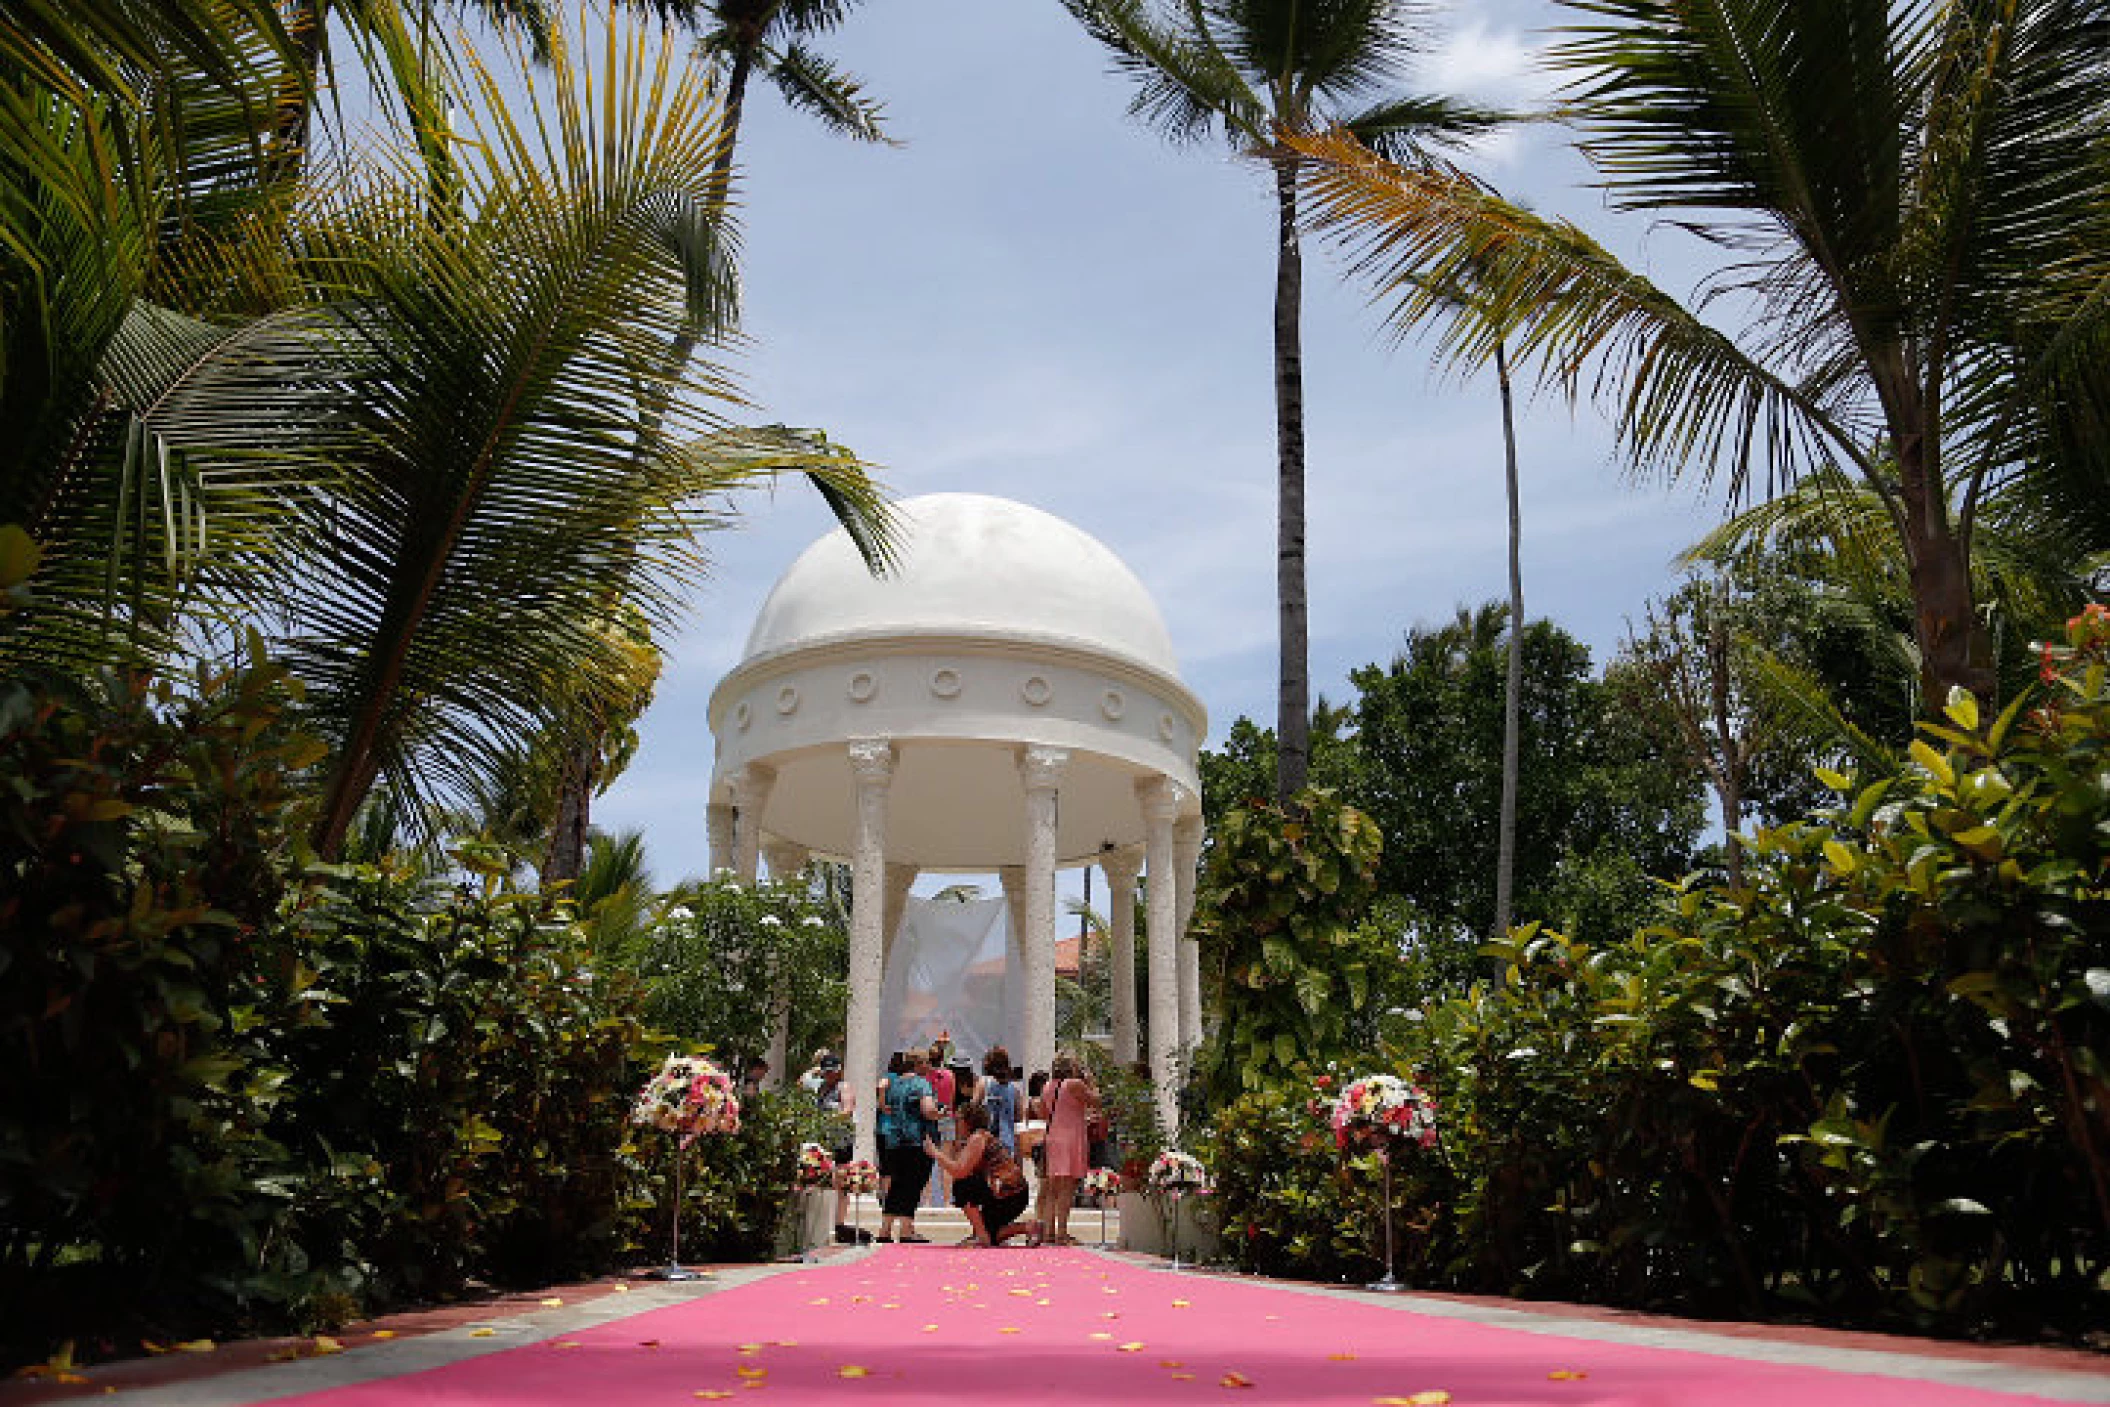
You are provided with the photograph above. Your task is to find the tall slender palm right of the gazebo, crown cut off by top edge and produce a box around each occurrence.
[1063,0,1502,799]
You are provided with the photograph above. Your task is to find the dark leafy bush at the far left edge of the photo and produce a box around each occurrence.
[0,664,317,1350]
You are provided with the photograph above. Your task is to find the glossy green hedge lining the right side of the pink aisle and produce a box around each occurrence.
[1215,608,2110,1333]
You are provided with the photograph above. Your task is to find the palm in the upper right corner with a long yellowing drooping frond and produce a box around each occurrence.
[1285,0,2110,707]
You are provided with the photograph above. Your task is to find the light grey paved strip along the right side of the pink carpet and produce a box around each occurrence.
[1139,1251,2110,1403]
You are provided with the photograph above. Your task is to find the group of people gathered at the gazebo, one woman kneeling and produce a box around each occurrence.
[802,1040,1101,1247]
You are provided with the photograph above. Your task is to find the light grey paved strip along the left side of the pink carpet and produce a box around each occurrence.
[91,1249,871,1407]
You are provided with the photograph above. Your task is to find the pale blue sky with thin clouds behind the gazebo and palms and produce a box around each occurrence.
[595,0,1722,892]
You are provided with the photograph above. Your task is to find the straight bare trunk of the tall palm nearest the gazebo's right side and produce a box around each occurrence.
[1274,158,1312,804]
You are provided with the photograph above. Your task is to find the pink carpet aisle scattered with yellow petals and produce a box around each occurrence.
[263,1247,2076,1407]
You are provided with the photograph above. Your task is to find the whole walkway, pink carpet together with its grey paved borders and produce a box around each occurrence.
[16,1247,2110,1407]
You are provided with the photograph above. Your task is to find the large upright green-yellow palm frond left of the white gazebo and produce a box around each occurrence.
[270,23,876,856]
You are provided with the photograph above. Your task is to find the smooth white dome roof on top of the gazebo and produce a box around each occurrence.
[743,494,1179,679]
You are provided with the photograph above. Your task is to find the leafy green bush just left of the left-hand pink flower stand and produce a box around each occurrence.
[274,867,644,1306]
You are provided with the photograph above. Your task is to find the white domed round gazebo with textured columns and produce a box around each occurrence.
[709,494,1207,1150]
